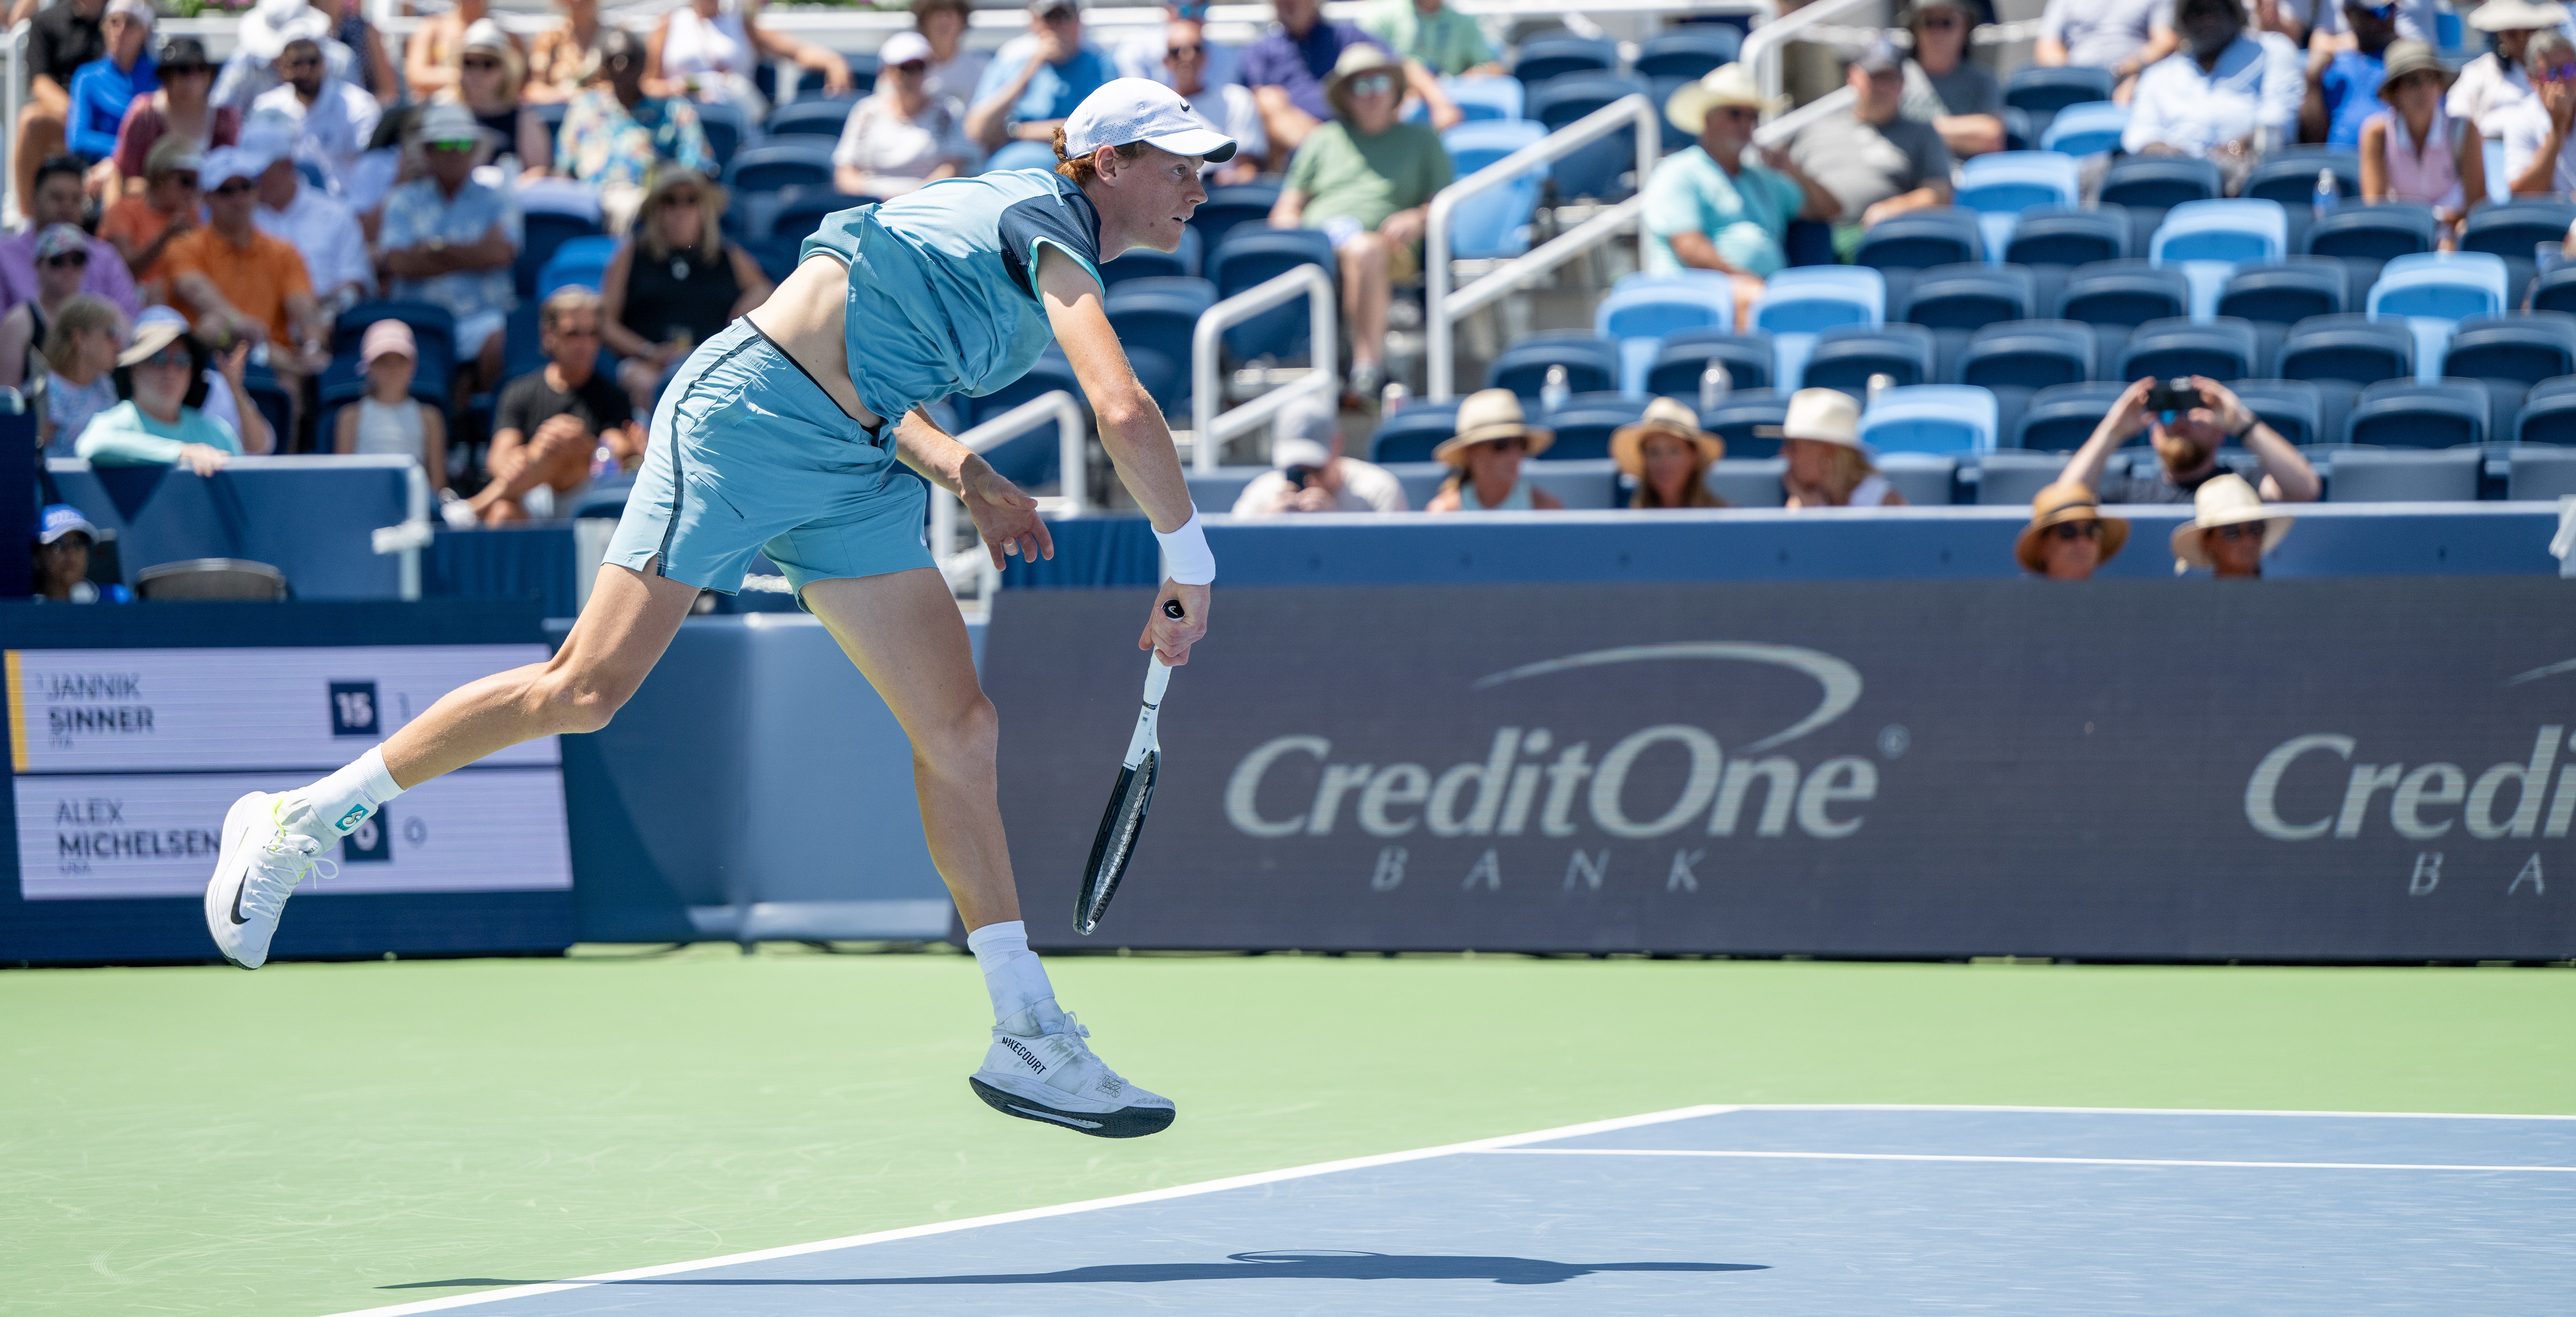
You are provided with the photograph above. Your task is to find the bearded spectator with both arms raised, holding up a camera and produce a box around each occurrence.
[2058,376,2318,503]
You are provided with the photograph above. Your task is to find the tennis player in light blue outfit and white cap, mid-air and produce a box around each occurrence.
[206,77,1234,1139]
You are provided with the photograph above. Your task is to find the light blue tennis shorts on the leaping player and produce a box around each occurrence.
[605,320,932,603]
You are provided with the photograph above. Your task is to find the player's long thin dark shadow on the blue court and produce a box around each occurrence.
[381,1250,1770,1289]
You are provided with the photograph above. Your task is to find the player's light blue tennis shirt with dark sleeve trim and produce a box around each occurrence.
[796,170,1100,420]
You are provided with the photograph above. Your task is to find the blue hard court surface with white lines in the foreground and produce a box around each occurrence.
[342,1108,2576,1317]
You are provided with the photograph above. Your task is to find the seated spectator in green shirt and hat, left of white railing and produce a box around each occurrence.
[1270,44,1450,399]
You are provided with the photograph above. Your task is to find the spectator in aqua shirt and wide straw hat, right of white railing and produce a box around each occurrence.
[1644,64,1842,325]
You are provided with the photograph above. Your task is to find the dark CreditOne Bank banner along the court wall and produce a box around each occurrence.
[984,577,2576,959]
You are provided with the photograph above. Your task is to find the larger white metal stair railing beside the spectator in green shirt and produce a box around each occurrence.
[1422,95,1664,402]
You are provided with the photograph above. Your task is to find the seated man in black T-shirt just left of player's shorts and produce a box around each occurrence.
[466,283,644,526]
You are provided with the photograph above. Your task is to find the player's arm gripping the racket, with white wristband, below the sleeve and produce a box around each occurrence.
[1038,248,1216,667]
